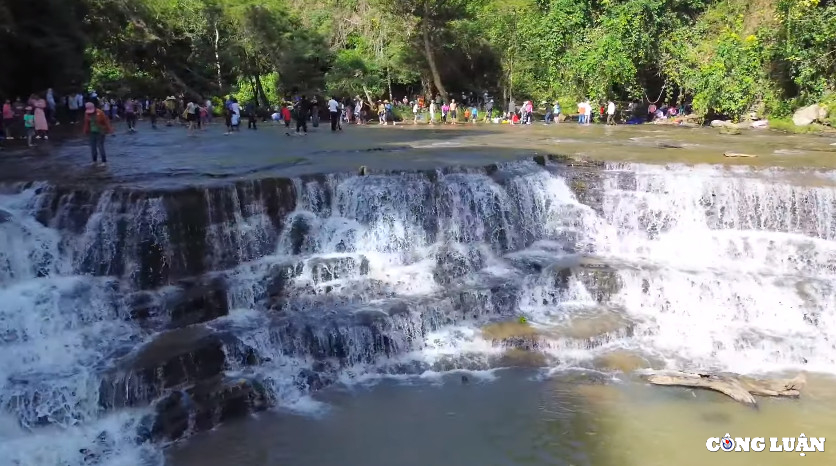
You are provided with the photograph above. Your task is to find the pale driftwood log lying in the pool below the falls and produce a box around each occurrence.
[647,372,806,406]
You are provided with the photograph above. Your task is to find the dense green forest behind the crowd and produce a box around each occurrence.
[0,0,836,117]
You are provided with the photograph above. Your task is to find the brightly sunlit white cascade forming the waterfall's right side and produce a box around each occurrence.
[599,166,836,372]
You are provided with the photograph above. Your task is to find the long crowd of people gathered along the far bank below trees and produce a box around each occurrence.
[0,89,688,165]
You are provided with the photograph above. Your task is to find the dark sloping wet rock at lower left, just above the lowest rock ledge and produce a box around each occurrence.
[99,327,226,408]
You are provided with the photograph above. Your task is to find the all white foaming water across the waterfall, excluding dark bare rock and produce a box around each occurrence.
[0,163,836,466]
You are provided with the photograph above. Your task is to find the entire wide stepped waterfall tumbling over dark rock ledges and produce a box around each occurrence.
[0,162,836,466]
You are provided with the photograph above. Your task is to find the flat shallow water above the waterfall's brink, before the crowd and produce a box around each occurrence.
[0,122,836,188]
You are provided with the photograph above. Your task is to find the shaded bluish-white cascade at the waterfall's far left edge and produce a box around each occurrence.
[0,186,162,466]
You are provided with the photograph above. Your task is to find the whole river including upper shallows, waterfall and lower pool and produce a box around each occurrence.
[0,127,836,466]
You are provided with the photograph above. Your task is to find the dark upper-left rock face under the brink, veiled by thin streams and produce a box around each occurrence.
[26,178,296,289]
